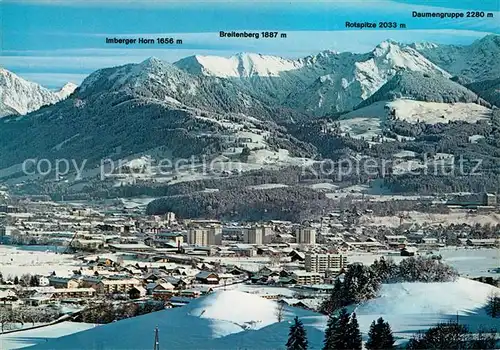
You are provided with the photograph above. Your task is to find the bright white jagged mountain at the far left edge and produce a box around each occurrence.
[0,68,76,117]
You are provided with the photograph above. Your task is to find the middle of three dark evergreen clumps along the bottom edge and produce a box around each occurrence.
[323,308,362,350]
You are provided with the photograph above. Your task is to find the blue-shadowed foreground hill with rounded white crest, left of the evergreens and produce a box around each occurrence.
[27,291,316,350]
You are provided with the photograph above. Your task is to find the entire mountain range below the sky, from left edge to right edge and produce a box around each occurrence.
[0,36,500,189]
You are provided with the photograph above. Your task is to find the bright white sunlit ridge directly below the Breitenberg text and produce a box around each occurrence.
[174,53,302,78]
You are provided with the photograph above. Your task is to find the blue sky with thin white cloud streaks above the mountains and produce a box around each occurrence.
[0,0,500,87]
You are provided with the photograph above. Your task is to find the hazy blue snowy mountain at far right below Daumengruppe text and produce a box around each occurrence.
[412,34,500,81]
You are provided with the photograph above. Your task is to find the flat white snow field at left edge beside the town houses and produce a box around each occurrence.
[0,245,78,278]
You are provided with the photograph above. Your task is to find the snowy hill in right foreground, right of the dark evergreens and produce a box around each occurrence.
[355,278,500,341]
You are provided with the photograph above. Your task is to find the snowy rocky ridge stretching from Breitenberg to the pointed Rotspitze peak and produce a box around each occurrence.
[174,40,451,115]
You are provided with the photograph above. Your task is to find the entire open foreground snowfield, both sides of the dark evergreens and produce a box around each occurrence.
[26,278,500,350]
